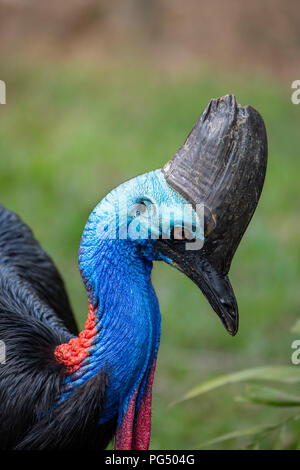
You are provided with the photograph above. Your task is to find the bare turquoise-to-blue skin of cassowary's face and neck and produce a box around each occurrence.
[62,170,203,424]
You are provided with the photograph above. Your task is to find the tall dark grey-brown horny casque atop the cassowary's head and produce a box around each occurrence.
[162,95,267,275]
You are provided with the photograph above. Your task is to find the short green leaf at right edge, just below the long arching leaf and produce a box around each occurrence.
[240,385,300,406]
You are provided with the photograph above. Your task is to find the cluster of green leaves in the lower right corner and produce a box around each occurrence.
[179,322,300,449]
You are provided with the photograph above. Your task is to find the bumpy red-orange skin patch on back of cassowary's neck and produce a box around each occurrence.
[54,305,97,374]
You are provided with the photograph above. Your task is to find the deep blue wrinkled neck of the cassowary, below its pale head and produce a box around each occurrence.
[68,218,161,422]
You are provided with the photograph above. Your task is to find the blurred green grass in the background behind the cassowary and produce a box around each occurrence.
[0,62,300,449]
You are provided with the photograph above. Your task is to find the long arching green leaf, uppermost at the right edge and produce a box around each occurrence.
[174,366,300,404]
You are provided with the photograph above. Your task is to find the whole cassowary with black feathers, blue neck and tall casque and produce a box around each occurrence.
[0,95,267,450]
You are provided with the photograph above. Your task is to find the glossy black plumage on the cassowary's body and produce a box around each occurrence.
[0,206,116,450]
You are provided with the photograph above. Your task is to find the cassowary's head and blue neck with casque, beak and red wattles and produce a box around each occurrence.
[79,95,267,448]
